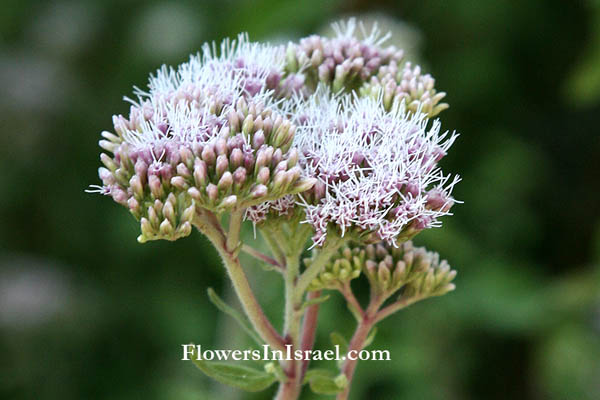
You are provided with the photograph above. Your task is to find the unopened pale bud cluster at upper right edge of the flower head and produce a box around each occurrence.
[360,61,449,117]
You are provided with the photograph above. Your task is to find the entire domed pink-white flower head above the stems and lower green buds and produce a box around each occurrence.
[89,20,458,245]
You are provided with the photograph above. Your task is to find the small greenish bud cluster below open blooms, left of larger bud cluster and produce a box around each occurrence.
[304,246,366,290]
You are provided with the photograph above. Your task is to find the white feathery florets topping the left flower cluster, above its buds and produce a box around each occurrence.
[115,34,285,151]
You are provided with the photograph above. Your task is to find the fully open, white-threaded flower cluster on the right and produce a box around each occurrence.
[255,87,458,245]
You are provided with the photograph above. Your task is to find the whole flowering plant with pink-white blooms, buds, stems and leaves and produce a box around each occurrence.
[91,20,459,400]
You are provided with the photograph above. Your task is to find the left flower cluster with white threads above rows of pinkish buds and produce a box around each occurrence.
[89,36,314,241]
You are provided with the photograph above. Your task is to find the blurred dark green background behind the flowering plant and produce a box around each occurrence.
[0,0,600,400]
